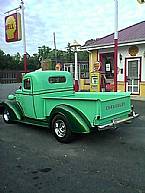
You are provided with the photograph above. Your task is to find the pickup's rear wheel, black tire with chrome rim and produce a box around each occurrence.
[52,114,73,143]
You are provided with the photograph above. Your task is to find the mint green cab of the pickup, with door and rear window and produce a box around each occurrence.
[16,71,74,119]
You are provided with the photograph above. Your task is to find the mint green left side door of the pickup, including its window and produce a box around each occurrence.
[21,77,36,118]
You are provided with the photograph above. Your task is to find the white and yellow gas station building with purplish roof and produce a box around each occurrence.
[80,21,145,96]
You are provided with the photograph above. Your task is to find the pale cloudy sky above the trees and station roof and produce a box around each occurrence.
[0,0,145,55]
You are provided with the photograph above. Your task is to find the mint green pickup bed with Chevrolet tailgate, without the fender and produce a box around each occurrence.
[43,92,131,127]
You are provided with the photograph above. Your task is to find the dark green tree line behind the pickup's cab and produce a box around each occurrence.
[0,43,88,71]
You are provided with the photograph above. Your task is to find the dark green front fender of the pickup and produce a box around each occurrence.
[2,99,23,120]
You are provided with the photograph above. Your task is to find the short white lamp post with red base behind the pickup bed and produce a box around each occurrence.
[70,40,81,92]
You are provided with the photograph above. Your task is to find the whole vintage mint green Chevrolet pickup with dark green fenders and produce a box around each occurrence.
[3,71,138,143]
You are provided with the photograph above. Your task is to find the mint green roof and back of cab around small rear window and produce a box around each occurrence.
[23,71,73,92]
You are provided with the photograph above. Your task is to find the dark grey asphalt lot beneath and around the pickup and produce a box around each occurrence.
[0,101,145,193]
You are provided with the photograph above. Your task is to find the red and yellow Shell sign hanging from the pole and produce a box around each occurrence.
[5,13,22,42]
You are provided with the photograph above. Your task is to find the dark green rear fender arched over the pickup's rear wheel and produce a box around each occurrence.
[50,105,91,133]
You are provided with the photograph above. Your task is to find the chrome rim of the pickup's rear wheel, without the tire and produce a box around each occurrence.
[54,120,66,137]
